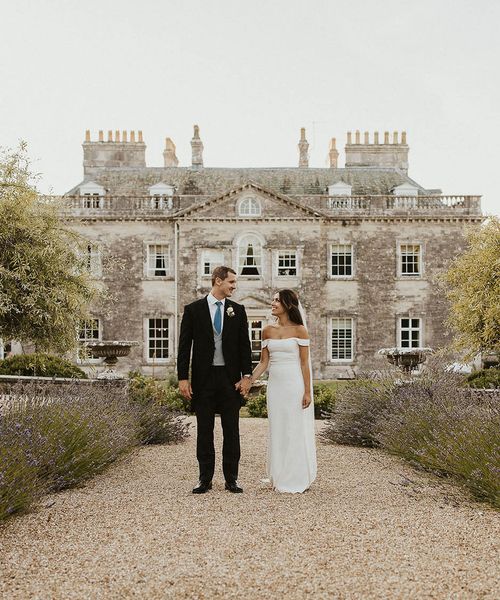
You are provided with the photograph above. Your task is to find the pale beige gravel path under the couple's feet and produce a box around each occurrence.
[0,419,500,600]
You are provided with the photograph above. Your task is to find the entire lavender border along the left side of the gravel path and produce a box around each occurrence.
[0,382,187,520]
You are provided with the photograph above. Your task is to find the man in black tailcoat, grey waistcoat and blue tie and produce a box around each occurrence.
[177,267,252,494]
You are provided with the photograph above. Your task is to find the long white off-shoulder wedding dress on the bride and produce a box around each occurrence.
[262,338,316,493]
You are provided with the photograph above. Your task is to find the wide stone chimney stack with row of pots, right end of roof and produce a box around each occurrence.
[345,131,409,173]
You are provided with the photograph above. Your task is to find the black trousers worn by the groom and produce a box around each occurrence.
[196,367,240,482]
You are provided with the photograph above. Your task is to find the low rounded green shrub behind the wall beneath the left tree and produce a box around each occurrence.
[0,352,87,379]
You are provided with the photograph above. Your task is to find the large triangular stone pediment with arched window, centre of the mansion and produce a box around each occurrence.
[176,182,325,221]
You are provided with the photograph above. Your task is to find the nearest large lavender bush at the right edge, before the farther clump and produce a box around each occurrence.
[375,371,500,508]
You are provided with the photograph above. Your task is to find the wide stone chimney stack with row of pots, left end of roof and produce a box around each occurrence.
[82,129,146,174]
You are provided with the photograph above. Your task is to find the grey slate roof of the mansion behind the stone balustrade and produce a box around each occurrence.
[67,167,426,197]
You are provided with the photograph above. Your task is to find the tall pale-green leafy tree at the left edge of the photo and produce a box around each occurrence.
[0,143,98,352]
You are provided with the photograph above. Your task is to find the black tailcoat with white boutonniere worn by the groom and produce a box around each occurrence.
[177,296,252,409]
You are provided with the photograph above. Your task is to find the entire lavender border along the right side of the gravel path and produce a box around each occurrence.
[322,359,500,507]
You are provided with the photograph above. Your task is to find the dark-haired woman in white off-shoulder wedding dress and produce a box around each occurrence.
[252,290,316,493]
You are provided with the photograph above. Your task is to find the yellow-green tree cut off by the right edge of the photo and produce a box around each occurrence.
[444,217,500,358]
